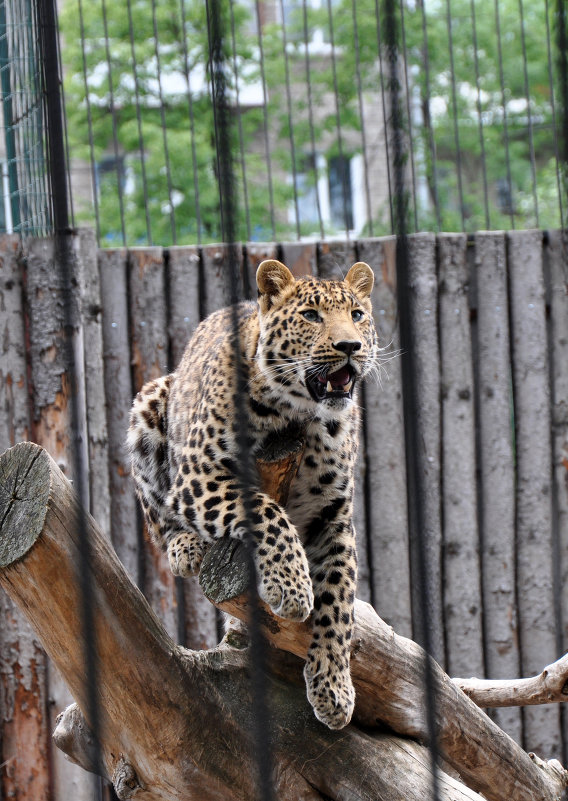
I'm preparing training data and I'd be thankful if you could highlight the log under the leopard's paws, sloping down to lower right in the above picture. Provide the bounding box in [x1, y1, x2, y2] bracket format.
[200, 542, 568, 801]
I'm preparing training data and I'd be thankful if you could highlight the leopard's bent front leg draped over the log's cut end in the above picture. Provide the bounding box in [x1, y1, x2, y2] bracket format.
[170, 466, 313, 620]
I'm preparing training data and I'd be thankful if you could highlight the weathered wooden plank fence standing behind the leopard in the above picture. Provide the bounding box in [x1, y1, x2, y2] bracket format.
[0, 231, 568, 801]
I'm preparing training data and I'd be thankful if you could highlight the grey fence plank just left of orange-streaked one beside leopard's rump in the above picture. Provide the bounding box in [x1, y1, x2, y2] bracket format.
[98, 249, 141, 583]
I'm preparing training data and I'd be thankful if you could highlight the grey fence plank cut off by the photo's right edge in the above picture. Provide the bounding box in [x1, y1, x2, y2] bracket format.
[545, 231, 568, 742]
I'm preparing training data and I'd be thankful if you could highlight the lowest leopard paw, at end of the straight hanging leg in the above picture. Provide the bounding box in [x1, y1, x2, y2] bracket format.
[304, 657, 355, 729]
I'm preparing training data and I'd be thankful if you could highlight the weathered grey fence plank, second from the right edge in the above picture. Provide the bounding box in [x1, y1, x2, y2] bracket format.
[507, 231, 561, 758]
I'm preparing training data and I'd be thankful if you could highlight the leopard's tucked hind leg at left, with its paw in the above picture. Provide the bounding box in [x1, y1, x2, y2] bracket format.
[128, 375, 203, 576]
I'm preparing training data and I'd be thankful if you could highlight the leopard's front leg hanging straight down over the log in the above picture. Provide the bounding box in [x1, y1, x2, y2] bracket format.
[304, 516, 357, 729]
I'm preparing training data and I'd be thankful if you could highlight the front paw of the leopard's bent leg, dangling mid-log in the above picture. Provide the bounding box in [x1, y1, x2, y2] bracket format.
[256, 546, 314, 621]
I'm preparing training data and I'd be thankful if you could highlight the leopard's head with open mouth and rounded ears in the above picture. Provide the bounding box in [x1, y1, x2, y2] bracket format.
[256, 259, 378, 414]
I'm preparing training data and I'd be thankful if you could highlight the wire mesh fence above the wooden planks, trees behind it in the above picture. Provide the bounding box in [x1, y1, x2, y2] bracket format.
[0, 0, 566, 245]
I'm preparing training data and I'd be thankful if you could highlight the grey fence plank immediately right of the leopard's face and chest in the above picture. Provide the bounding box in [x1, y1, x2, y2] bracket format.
[357, 237, 412, 637]
